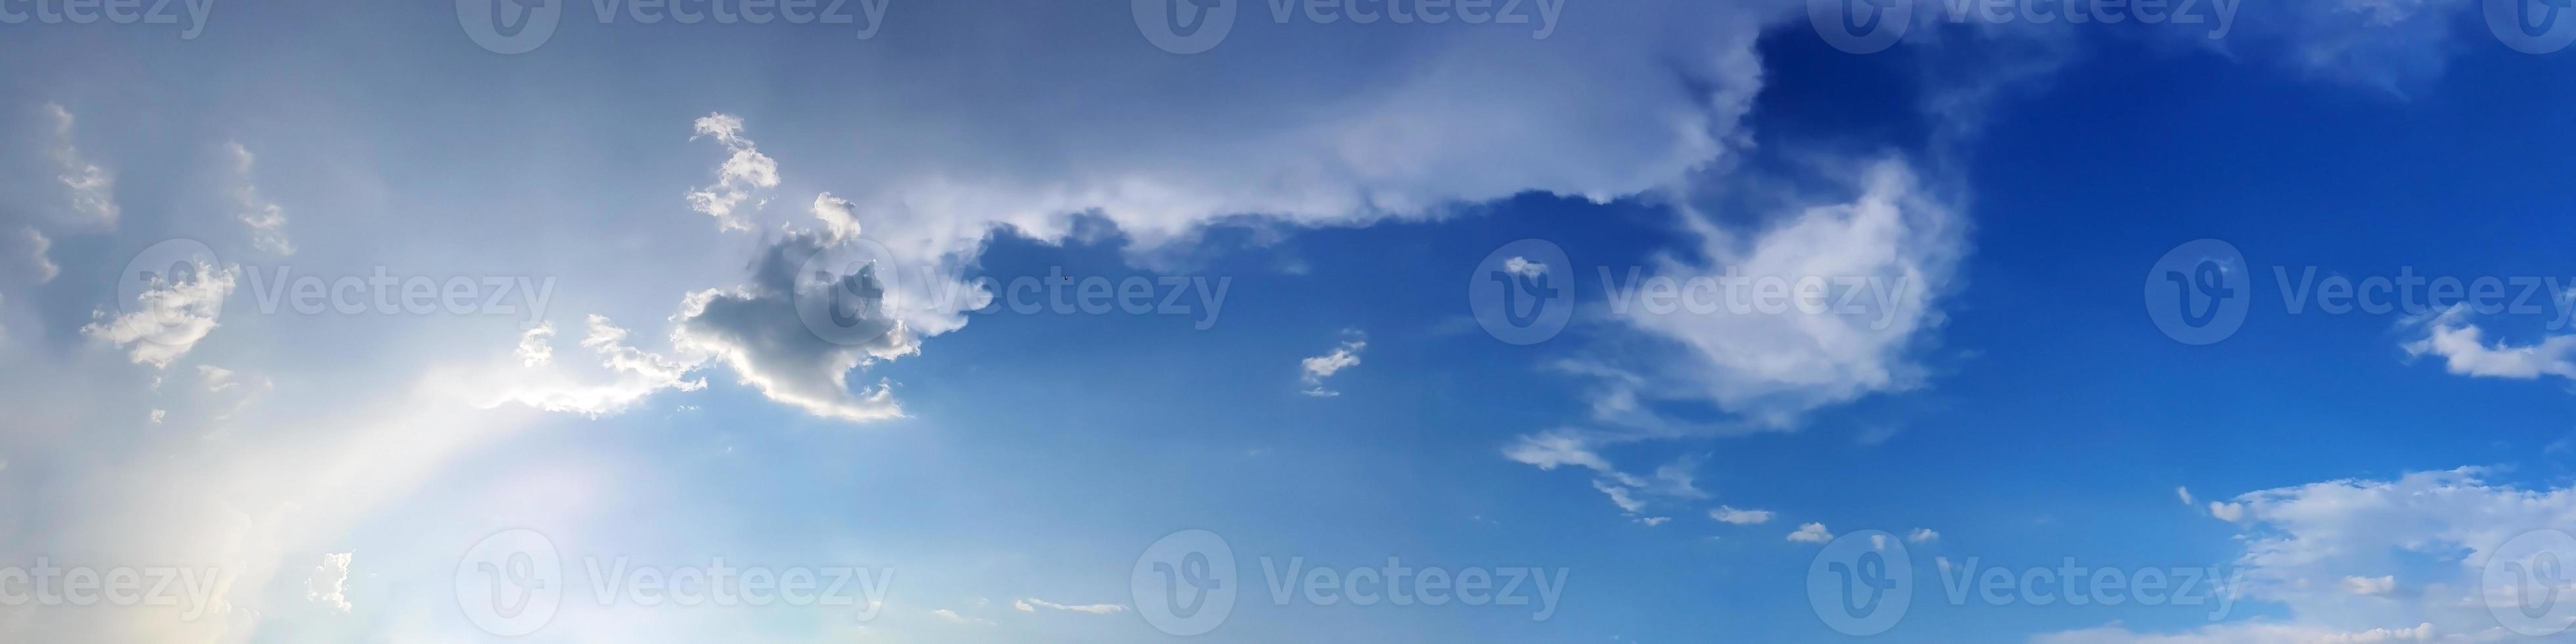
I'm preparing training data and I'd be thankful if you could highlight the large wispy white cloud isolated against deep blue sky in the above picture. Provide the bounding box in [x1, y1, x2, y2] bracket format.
[1592, 160, 1966, 425]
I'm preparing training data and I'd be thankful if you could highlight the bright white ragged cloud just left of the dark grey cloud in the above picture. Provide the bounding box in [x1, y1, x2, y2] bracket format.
[471, 314, 706, 417]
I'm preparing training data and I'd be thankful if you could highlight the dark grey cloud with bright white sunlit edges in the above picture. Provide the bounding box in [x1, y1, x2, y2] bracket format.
[672, 235, 948, 420]
